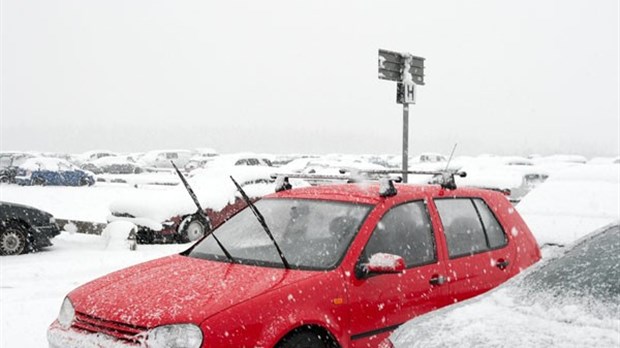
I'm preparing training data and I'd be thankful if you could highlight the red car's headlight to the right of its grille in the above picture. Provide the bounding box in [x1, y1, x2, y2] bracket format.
[146, 324, 202, 348]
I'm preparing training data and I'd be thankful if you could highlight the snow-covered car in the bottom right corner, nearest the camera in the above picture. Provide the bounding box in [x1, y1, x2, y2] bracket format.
[384, 223, 620, 347]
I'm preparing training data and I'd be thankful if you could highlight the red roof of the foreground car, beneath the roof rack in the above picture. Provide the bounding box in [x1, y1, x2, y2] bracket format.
[265, 182, 500, 205]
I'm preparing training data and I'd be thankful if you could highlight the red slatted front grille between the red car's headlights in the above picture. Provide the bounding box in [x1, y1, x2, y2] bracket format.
[72, 312, 147, 345]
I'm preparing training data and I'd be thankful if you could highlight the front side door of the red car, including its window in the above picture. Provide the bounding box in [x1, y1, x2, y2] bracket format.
[349, 200, 449, 347]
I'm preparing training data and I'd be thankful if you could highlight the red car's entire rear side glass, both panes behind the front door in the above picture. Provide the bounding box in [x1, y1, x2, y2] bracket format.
[435, 198, 507, 258]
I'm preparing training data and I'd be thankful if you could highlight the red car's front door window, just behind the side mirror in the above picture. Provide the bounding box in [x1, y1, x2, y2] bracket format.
[364, 201, 436, 267]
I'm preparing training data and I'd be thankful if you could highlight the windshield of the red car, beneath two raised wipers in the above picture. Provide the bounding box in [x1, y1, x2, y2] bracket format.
[189, 198, 372, 270]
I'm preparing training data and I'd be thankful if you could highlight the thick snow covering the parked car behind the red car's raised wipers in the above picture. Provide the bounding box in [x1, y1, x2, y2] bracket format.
[110, 167, 275, 222]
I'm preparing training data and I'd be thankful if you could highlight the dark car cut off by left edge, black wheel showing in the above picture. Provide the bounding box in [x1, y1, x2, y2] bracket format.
[0, 202, 60, 255]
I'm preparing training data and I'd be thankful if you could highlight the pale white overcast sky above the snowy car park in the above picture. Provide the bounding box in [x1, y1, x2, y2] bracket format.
[0, 0, 620, 156]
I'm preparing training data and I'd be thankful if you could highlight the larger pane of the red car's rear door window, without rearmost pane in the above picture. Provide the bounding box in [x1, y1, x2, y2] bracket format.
[435, 198, 488, 258]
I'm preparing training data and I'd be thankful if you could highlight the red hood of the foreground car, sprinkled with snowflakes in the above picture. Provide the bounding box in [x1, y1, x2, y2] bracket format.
[69, 255, 321, 328]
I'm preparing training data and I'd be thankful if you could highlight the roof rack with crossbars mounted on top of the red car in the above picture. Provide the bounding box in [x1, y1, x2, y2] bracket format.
[271, 168, 467, 197]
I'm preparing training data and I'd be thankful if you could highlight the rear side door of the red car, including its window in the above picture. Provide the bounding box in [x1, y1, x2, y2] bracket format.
[434, 197, 514, 302]
